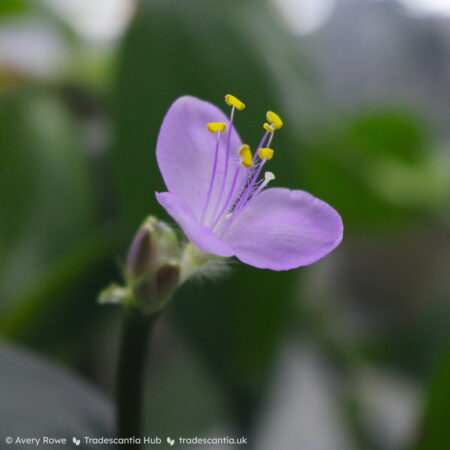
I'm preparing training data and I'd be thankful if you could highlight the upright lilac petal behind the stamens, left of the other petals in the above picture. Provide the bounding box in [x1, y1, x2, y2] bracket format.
[156, 96, 244, 220]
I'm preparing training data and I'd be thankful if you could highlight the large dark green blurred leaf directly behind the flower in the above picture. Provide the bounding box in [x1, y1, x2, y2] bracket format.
[114, 0, 298, 426]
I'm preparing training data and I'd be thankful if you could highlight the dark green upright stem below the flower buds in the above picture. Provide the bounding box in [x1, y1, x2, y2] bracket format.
[116, 309, 158, 450]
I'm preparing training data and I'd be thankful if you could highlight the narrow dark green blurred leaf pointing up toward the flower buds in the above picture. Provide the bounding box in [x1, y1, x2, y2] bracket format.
[0, 230, 116, 347]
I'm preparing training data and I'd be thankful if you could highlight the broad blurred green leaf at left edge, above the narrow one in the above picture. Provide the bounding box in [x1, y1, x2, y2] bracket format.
[0, 87, 93, 309]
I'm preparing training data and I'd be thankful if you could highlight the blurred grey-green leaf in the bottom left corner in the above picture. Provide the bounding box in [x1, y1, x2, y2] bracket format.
[0, 345, 113, 442]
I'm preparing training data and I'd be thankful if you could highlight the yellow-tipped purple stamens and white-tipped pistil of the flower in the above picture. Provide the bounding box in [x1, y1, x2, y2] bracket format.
[201, 94, 283, 235]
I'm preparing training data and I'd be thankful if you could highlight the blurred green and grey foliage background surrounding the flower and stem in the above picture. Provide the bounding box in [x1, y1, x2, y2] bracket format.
[0, 0, 450, 450]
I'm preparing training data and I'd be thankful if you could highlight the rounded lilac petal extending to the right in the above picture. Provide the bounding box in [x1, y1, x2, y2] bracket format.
[223, 188, 343, 270]
